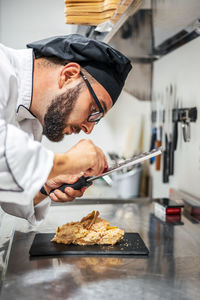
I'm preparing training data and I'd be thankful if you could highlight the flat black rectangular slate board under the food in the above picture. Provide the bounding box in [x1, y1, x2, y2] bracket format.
[29, 232, 149, 256]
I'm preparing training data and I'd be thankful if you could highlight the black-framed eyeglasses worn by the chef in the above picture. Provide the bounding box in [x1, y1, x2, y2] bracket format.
[80, 71, 104, 124]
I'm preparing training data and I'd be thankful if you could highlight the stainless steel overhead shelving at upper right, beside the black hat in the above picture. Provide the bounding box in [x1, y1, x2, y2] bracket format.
[78, 0, 200, 100]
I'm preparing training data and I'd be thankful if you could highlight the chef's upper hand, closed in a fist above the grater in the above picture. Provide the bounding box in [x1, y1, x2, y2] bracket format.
[49, 140, 107, 179]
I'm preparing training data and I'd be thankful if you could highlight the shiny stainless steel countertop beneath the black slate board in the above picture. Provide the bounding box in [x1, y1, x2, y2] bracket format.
[0, 199, 200, 300]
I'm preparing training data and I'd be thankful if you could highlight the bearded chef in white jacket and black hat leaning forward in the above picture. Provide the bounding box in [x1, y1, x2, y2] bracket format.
[0, 34, 131, 224]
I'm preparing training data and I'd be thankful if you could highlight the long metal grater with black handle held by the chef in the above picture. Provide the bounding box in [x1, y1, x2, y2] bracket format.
[50, 147, 162, 193]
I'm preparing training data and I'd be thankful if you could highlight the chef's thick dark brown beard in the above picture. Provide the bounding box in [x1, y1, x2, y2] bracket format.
[43, 83, 82, 142]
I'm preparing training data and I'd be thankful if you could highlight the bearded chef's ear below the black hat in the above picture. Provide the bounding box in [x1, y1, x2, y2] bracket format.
[58, 62, 81, 88]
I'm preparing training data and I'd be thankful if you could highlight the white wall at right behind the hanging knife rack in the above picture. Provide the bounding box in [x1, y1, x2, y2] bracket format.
[151, 38, 200, 197]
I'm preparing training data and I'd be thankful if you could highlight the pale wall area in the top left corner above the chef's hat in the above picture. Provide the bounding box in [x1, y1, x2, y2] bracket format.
[0, 0, 76, 48]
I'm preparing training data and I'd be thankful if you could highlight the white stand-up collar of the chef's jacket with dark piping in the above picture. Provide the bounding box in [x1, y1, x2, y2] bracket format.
[16, 49, 36, 122]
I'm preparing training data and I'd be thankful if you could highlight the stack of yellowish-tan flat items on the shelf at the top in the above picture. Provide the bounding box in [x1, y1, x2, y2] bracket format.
[65, 0, 121, 26]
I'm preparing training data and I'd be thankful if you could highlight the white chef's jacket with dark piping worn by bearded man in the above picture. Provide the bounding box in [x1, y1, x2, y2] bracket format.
[0, 44, 54, 224]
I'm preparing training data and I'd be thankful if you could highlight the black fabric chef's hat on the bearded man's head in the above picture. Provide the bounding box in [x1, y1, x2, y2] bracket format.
[27, 34, 132, 104]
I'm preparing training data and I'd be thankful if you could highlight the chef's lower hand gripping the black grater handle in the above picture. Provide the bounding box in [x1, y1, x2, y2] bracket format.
[44, 175, 86, 202]
